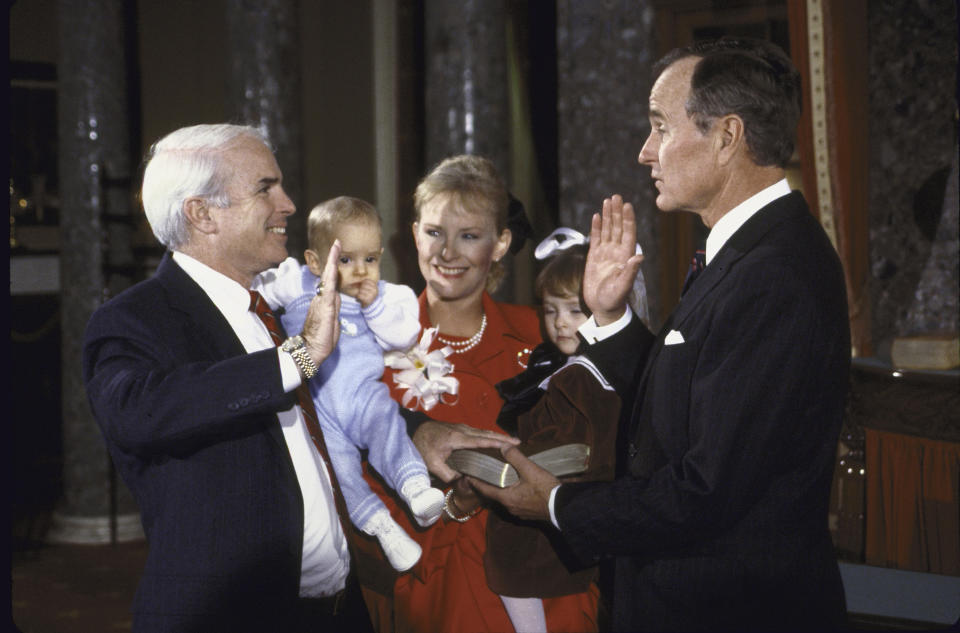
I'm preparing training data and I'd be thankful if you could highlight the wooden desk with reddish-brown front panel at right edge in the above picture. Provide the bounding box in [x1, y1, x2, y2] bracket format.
[831, 359, 960, 575]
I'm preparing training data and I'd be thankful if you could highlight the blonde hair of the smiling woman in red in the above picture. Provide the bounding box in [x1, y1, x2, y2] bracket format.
[413, 154, 510, 293]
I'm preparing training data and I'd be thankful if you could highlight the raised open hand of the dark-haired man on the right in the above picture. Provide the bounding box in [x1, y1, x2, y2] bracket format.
[583, 195, 643, 325]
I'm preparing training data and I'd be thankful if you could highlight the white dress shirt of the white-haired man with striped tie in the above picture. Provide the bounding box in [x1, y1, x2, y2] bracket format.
[173, 252, 350, 598]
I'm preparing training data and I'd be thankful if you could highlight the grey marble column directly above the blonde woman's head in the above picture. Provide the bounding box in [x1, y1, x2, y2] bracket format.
[424, 0, 510, 178]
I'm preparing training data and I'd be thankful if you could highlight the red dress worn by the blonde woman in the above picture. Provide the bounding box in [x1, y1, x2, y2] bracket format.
[368, 293, 599, 633]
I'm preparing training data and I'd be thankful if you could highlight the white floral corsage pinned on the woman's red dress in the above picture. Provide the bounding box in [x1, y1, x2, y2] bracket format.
[383, 327, 460, 411]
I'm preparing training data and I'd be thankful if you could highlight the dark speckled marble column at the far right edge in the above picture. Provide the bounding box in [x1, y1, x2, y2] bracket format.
[867, 0, 960, 346]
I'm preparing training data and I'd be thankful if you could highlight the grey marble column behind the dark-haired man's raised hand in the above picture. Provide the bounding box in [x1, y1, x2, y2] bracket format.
[557, 0, 672, 327]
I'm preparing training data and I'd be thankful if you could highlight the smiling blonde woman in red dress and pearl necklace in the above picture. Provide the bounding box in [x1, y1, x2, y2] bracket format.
[362, 155, 597, 633]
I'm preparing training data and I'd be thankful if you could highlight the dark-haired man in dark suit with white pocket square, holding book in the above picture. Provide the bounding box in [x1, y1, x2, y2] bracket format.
[476, 40, 850, 631]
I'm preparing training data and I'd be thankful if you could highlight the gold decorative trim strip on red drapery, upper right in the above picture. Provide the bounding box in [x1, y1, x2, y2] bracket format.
[807, 0, 837, 248]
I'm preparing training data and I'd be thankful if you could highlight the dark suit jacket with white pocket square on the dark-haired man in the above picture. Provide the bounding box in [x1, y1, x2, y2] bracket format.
[556, 192, 850, 631]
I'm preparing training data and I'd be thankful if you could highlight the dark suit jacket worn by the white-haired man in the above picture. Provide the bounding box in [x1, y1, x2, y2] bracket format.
[83, 254, 318, 631]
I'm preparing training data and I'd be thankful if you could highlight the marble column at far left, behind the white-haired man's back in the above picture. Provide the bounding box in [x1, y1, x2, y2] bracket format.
[47, 0, 143, 543]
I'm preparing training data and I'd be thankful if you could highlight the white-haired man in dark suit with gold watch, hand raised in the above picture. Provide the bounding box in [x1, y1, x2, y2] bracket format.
[83, 124, 370, 632]
